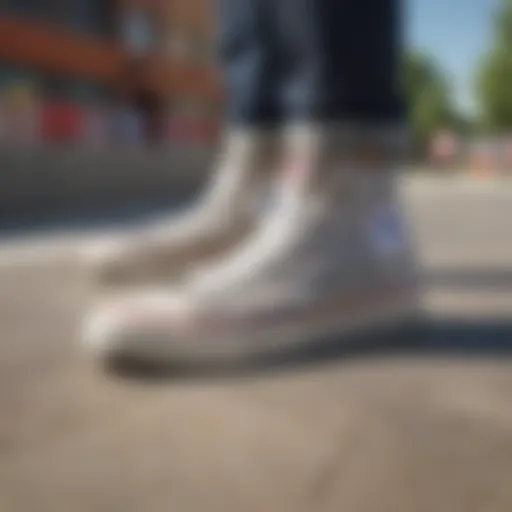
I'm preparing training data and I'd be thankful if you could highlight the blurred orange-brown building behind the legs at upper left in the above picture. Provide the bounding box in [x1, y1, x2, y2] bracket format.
[0, 0, 221, 145]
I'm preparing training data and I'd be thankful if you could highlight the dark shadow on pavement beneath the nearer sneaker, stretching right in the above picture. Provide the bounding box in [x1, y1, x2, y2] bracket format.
[106, 317, 512, 381]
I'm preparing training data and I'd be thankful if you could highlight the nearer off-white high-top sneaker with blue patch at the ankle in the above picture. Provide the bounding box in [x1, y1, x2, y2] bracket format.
[83, 127, 417, 363]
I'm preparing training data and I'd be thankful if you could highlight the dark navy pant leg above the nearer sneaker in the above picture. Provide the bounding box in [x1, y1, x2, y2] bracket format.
[274, 0, 404, 123]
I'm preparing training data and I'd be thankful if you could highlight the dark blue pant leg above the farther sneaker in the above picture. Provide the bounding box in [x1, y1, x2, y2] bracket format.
[217, 0, 283, 126]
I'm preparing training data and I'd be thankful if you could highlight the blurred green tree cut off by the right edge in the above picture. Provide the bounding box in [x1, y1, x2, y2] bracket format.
[476, 0, 512, 133]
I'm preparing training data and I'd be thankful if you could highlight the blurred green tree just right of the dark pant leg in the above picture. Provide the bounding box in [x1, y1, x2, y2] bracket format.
[403, 52, 461, 151]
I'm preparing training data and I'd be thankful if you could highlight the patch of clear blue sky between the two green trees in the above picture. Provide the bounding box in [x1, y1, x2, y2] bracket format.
[406, 0, 499, 110]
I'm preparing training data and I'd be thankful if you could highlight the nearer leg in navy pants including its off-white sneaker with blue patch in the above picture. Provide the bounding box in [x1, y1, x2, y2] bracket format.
[86, 0, 415, 362]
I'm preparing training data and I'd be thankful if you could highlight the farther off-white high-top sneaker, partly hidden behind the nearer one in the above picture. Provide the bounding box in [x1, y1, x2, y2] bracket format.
[85, 131, 277, 285]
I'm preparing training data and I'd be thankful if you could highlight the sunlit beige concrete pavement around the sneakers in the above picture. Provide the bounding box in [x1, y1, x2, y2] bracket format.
[0, 180, 512, 512]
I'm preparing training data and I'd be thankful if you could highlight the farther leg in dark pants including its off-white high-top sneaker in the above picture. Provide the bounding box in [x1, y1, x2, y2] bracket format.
[88, 0, 282, 286]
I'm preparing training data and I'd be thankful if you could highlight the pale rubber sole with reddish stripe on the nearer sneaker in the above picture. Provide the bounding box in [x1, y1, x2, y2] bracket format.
[83, 282, 421, 366]
